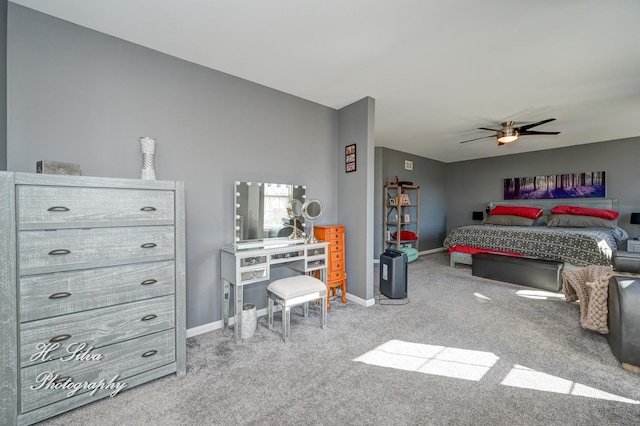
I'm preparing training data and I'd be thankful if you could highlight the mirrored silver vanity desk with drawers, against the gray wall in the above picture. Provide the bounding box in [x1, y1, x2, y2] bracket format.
[220, 238, 329, 343]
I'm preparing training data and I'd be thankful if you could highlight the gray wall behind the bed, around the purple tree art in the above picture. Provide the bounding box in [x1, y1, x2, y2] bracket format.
[446, 137, 640, 237]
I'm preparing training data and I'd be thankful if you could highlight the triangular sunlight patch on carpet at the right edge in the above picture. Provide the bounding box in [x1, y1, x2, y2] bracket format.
[501, 364, 640, 404]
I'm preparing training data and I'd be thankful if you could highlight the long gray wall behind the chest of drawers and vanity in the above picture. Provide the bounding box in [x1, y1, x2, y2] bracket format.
[7, 3, 343, 328]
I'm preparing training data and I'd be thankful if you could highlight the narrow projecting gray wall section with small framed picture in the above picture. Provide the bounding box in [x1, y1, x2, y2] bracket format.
[336, 98, 375, 305]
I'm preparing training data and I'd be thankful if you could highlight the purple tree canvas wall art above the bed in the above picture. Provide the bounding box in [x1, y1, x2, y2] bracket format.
[504, 172, 606, 200]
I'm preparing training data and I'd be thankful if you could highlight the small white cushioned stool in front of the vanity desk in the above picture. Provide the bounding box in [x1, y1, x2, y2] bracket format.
[267, 275, 327, 343]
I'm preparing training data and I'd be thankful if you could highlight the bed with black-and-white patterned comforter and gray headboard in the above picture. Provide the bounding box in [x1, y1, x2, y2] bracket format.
[443, 198, 628, 267]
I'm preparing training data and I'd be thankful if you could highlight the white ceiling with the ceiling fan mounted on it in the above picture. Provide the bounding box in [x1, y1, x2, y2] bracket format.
[12, 0, 640, 162]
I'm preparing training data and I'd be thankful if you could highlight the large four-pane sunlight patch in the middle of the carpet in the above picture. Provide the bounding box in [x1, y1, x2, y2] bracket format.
[354, 340, 499, 381]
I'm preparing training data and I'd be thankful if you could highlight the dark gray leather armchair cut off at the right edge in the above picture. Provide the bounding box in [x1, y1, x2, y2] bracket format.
[607, 251, 640, 373]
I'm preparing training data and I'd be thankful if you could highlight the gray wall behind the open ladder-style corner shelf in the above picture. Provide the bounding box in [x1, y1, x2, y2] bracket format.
[374, 147, 447, 258]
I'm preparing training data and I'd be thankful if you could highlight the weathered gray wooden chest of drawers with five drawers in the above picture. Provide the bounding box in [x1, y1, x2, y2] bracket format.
[0, 172, 186, 425]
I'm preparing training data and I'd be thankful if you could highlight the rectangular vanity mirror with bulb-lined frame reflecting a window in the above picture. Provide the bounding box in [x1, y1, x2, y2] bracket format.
[234, 182, 307, 246]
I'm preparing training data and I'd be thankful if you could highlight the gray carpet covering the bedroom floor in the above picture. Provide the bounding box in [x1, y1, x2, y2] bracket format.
[42, 253, 640, 425]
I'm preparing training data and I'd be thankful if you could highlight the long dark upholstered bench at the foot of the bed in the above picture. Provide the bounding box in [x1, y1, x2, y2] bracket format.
[471, 253, 563, 292]
